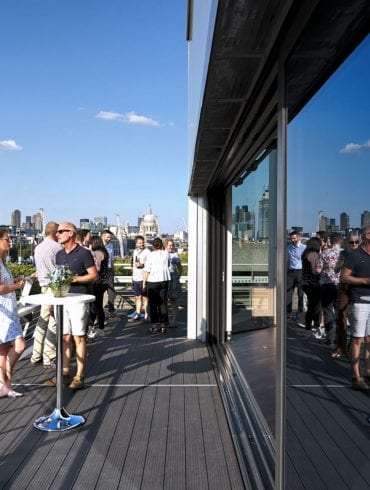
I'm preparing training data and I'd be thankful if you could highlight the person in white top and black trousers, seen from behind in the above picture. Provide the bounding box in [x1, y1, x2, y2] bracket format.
[143, 238, 171, 333]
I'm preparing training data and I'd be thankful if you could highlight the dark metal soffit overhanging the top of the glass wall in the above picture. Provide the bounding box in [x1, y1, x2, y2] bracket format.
[189, 0, 370, 195]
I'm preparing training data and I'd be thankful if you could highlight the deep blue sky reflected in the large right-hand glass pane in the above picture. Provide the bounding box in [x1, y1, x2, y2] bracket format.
[287, 37, 370, 232]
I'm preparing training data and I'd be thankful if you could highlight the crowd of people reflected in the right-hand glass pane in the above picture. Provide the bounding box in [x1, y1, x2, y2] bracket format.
[286, 226, 370, 391]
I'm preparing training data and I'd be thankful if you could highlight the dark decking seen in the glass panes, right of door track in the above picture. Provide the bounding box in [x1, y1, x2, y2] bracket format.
[232, 321, 370, 490]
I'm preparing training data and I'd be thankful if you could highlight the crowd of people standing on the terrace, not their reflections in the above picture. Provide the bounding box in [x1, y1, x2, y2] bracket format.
[0, 221, 181, 397]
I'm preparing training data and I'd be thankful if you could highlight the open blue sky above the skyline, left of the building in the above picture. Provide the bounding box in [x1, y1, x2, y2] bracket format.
[0, 0, 188, 233]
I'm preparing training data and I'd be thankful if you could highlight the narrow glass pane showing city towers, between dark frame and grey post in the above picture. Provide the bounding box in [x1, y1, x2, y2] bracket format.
[231, 156, 275, 432]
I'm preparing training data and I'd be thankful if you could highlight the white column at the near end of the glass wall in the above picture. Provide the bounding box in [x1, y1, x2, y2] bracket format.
[187, 196, 207, 342]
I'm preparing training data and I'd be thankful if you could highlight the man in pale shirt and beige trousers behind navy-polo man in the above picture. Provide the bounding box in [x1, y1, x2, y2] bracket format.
[31, 221, 63, 367]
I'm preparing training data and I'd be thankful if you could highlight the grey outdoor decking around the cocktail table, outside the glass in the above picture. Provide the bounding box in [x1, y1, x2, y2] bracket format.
[0, 316, 244, 490]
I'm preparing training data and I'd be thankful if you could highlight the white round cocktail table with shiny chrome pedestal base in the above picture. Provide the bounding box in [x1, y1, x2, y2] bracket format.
[20, 293, 95, 432]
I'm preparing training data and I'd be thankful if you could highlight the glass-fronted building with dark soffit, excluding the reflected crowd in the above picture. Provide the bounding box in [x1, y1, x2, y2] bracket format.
[187, 0, 370, 489]
